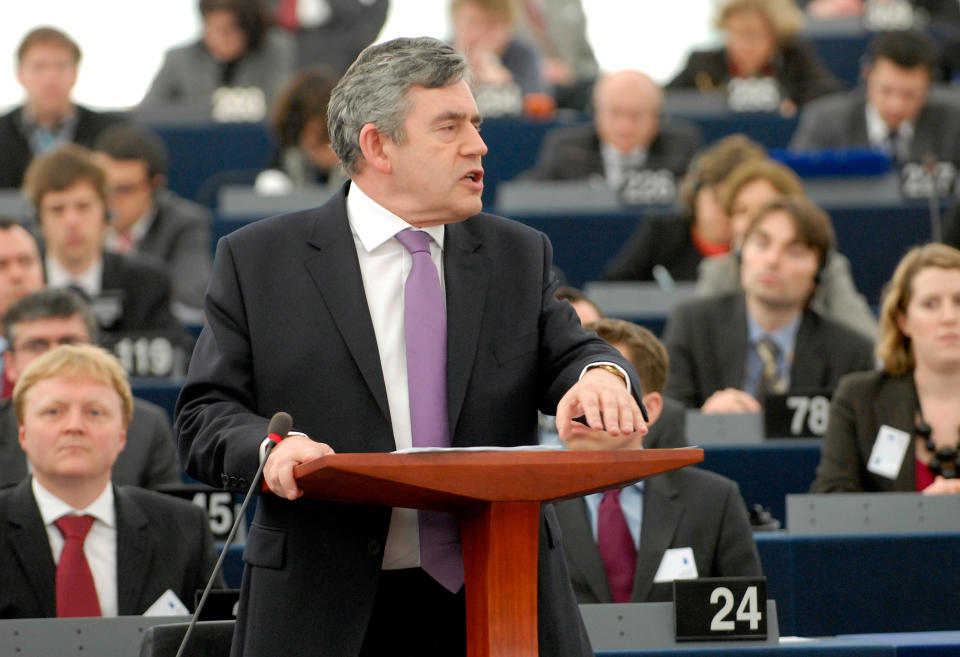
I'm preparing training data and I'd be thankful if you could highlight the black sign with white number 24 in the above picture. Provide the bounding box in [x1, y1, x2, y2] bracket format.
[673, 577, 767, 641]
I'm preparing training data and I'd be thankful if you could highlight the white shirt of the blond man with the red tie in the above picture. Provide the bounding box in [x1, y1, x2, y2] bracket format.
[31, 477, 119, 617]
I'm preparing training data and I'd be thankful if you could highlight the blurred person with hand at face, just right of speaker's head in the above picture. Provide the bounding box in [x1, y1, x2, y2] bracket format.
[450, 0, 552, 116]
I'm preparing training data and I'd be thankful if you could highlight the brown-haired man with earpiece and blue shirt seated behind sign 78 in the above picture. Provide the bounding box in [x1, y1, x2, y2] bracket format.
[663, 197, 874, 413]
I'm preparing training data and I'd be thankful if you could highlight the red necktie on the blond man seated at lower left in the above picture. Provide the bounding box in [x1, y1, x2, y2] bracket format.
[54, 516, 101, 618]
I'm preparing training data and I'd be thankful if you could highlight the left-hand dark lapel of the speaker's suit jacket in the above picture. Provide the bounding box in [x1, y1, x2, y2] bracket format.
[306, 193, 390, 419]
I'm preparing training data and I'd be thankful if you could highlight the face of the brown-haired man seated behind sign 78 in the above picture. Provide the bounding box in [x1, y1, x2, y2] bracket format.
[740, 210, 818, 312]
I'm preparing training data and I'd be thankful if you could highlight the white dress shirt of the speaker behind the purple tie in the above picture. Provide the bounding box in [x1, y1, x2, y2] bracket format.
[347, 183, 446, 570]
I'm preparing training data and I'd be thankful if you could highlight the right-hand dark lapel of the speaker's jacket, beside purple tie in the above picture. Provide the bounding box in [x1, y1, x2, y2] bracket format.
[443, 223, 492, 436]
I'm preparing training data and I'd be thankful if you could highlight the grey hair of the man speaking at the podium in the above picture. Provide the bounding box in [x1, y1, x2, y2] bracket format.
[327, 37, 469, 173]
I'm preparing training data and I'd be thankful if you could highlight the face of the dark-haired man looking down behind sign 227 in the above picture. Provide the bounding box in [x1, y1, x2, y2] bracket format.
[867, 57, 930, 130]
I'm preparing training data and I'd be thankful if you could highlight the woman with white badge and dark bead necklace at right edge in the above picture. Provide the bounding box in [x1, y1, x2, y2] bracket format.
[811, 244, 960, 494]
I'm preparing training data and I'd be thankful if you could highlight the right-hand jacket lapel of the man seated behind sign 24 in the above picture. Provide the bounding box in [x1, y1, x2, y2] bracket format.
[632, 477, 683, 602]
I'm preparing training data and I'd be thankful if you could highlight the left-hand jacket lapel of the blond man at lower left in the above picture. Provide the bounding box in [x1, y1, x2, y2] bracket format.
[3, 478, 57, 617]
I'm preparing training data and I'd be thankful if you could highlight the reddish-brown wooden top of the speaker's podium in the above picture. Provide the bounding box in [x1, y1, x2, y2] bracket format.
[294, 448, 703, 510]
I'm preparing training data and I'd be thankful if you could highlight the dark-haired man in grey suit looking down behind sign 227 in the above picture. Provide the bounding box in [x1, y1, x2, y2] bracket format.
[790, 31, 960, 166]
